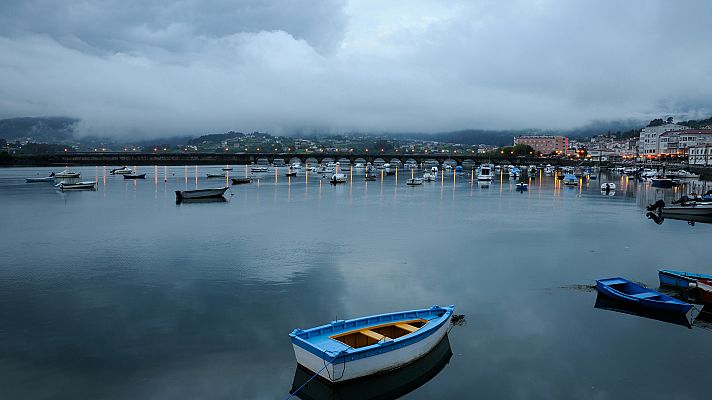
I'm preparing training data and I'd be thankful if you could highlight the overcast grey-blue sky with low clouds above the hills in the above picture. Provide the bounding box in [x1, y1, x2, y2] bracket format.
[0, 0, 712, 137]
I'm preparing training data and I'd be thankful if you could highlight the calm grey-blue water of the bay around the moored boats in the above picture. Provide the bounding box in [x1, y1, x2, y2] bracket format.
[0, 166, 712, 399]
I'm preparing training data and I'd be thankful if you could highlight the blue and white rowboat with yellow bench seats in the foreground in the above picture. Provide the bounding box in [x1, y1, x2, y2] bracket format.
[289, 306, 455, 383]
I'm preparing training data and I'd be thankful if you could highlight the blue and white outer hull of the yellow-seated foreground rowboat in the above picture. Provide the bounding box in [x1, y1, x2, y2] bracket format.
[290, 307, 453, 383]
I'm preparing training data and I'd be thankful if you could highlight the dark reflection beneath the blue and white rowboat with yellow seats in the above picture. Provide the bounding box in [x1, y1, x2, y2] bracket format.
[290, 335, 452, 400]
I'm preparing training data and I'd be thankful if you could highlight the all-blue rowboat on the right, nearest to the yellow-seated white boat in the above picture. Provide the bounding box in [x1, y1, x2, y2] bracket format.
[596, 278, 692, 314]
